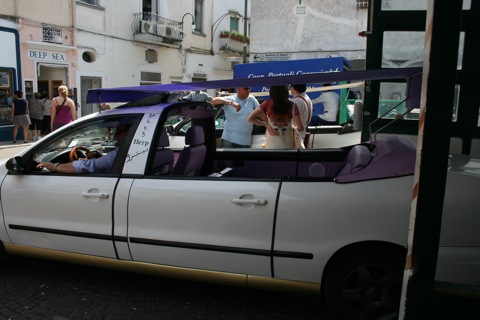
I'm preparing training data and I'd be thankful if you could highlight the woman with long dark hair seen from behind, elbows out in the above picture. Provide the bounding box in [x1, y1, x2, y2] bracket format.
[248, 86, 303, 149]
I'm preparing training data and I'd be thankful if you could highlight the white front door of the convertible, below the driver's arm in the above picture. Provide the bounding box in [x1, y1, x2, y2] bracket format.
[2, 175, 117, 258]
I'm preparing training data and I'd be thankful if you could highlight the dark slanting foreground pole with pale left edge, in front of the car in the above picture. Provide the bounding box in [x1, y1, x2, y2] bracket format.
[400, 0, 462, 320]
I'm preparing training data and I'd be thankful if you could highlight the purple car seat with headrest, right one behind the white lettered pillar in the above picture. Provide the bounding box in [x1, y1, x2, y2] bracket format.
[173, 126, 207, 176]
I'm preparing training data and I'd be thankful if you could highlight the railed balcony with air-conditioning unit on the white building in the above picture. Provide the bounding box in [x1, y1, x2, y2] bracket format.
[132, 12, 185, 45]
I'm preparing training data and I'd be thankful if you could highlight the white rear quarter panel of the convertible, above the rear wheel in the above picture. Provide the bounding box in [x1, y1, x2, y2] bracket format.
[275, 176, 413, 282]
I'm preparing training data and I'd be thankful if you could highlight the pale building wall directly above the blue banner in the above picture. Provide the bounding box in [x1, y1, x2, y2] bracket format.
[250, 0, 368, 62]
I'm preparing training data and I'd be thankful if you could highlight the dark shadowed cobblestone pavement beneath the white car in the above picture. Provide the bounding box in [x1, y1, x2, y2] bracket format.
[0, 257, 331, 320]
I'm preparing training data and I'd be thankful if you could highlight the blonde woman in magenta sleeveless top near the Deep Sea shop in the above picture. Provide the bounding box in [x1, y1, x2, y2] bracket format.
[50, 86, 77, 131]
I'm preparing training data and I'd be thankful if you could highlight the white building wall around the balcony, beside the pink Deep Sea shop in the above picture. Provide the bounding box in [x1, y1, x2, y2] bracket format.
[76, 0, 192, 111]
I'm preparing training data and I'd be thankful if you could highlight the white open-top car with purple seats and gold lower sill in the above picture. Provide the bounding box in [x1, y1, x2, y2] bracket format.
[0, 84, 480, 319]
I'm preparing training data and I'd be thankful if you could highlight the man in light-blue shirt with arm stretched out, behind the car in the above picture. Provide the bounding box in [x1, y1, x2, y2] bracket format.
[212, 87, 259, 148]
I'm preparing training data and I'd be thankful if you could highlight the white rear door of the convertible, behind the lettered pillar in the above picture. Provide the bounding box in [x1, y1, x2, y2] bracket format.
[128, 179, 279, 276]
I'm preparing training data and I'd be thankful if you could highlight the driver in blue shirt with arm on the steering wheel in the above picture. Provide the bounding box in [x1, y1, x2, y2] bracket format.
[37, 124, 130, 173]
